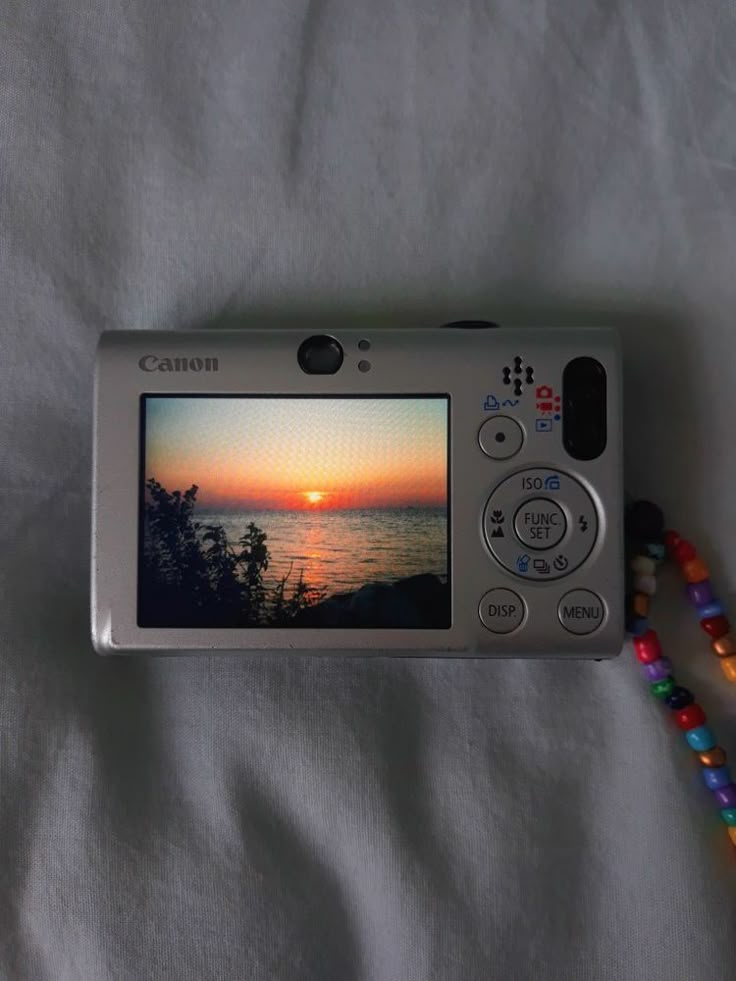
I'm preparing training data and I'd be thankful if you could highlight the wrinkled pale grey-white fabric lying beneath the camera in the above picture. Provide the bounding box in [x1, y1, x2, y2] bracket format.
[0, 0, 736, 981]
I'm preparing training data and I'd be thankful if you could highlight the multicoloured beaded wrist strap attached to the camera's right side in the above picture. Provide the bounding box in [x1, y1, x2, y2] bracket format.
[626, 501, 736, 846]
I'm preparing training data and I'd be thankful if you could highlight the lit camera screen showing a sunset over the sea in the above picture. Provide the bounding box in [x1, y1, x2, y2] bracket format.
[138, 396, 450, 629]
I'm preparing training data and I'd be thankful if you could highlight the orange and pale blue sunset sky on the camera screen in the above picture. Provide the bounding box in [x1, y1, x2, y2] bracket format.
[146, 396, 448, 510]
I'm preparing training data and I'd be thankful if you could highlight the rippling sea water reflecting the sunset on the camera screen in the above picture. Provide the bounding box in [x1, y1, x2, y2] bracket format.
[195, 507, 448, 595]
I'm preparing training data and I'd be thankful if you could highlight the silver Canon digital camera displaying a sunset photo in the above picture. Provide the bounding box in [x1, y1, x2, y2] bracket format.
[92, 322, 624, 658]
